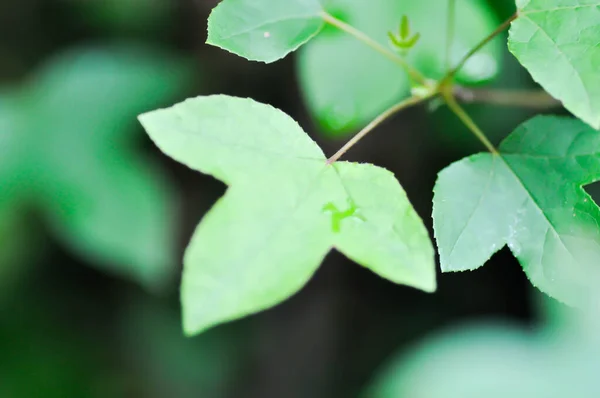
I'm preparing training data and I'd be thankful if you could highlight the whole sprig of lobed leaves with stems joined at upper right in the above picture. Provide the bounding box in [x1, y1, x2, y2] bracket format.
[140, 0, 600, 334]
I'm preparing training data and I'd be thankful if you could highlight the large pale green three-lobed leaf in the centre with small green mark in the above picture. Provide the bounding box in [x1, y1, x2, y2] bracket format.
[140, 96, 435, 334]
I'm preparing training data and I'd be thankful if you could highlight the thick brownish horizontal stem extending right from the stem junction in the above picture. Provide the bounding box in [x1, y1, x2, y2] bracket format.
[453, 86, 562, 109]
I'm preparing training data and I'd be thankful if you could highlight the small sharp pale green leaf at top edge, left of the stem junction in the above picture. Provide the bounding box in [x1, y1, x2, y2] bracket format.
[206, 0, 323, 62]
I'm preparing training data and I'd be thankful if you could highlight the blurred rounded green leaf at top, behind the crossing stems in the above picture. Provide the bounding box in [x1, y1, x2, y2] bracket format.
[298, 0, 502, 136]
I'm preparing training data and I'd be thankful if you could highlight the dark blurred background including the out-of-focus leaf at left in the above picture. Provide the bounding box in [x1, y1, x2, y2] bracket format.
[0, 0, 588, 398]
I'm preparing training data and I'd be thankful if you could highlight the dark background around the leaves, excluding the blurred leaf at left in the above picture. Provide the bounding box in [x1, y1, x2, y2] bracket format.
[0, 0, 556, 398]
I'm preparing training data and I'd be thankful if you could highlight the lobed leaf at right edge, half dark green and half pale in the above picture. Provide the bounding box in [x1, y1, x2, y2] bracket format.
[433, 116, 600, 305]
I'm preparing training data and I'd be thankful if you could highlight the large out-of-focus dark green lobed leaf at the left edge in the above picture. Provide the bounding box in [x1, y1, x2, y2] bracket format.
[0, 46, 184, 286]
